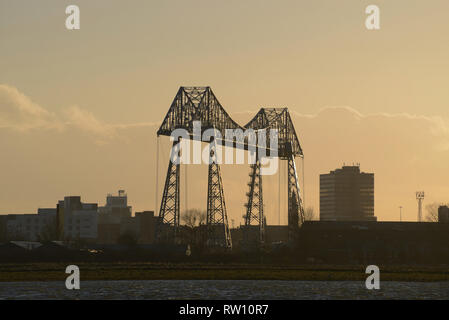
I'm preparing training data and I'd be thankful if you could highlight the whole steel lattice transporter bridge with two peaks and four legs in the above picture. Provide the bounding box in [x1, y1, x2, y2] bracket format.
[157, 87, 304, 248]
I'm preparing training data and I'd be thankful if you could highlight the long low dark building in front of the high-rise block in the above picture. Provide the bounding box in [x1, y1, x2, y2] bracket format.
[298, 221, 449, 266]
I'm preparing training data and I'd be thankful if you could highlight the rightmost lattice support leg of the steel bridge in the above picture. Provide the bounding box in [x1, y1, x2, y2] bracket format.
[287, 155, 304, 243]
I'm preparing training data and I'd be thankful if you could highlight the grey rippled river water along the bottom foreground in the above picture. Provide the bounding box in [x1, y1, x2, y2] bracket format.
[0, 280, 449, 300]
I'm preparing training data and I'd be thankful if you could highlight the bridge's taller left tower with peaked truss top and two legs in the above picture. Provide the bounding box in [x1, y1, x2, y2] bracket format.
[156, 87, 236, 250]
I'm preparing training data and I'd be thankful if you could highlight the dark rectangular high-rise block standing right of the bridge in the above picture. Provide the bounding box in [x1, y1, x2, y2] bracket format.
[320, 166, 377, 221]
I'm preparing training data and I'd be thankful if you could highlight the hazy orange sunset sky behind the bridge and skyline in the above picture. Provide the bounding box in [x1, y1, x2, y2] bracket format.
[0, 0, 449, 225]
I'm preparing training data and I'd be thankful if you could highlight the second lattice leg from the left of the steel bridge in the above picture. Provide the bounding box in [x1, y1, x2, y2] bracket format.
[206, 151, 232, 250]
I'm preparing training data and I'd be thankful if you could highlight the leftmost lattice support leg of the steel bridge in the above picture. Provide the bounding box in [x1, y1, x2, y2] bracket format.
[156, 141, 180, 243]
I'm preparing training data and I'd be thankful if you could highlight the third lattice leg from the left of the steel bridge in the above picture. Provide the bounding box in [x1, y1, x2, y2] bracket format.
[243, 160, 265, 248]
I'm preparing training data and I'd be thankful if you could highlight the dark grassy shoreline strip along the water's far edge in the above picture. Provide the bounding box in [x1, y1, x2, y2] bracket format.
[0, 262, 449, 282]
